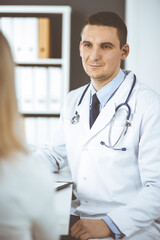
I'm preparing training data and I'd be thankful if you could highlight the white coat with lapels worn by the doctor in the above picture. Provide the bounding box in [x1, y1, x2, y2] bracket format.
[39, 72, 160, 240]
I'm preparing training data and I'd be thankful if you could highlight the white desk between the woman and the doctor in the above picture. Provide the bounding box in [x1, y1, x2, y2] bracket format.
[55, 168, 72, 235]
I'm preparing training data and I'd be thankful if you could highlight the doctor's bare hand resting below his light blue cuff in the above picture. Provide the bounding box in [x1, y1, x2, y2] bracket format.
[71, 219, 112, 240]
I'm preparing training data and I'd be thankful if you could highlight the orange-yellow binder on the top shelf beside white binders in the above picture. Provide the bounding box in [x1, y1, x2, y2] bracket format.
[38, 18, 50, 58]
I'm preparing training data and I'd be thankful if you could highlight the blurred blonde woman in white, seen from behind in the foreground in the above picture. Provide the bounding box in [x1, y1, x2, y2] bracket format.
[0, 32, 58, 240]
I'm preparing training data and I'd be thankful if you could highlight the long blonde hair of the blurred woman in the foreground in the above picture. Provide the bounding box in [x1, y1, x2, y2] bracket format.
[0, 32, 27, 158]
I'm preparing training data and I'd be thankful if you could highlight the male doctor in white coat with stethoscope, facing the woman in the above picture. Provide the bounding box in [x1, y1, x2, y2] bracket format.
[38, 12, 160, 240]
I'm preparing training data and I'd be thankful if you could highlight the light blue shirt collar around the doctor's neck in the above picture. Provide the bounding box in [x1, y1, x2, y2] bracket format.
[91, 69, 125, 108]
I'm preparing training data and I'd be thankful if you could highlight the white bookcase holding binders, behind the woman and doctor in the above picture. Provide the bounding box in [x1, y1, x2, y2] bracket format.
[0, 5, 71, 146]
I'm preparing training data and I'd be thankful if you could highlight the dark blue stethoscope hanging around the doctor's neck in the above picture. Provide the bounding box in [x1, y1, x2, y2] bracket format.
[71, 75, 136, 151]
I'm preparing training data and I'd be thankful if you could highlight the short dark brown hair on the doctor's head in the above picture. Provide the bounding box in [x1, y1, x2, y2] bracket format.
[81, 12, 127, 48]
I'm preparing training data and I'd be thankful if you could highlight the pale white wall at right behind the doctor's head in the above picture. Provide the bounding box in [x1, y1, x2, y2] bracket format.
[125, 0, 160, 93]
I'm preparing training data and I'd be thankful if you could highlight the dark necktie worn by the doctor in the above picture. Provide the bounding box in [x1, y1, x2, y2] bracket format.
[90, 93, 99, 128]
